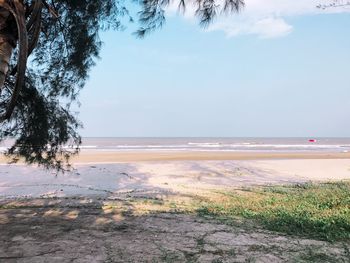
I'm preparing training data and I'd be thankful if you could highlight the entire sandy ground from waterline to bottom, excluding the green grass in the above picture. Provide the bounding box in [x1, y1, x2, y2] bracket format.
[0, 151, 350, 263]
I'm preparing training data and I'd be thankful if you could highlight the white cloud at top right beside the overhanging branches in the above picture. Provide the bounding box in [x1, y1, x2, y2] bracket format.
[170, 0, 350, 38]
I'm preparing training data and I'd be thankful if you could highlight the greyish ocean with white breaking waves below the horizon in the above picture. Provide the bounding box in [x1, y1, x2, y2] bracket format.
[72, 137, 350, 152]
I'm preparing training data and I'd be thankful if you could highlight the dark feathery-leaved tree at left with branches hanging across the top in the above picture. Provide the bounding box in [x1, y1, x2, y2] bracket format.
[0, 0, 244, 169]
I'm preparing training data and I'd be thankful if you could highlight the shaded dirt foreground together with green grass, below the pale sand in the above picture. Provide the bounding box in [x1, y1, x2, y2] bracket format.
[0, 181, 350, 262]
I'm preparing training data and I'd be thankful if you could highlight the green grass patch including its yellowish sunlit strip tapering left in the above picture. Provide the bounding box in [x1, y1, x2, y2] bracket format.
[99, 181, 350, 242]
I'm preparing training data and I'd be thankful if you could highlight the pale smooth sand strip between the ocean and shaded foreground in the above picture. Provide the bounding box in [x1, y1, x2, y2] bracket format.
[0, 151, 350, 198]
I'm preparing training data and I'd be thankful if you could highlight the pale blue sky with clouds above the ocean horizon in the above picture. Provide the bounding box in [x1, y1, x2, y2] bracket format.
[79, 0, 350, 137]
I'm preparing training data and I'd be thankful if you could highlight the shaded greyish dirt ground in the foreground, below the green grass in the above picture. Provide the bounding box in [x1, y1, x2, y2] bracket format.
[0, 197, 350, 263]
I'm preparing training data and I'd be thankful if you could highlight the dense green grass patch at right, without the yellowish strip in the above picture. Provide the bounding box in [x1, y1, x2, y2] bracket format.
[197, 181, 350, 241]
